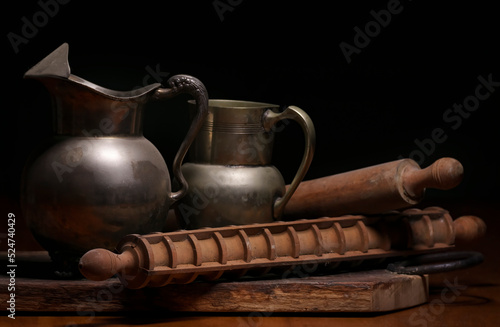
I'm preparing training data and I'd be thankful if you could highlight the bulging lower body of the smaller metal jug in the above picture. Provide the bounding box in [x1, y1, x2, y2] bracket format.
[175, 163, 285, 229]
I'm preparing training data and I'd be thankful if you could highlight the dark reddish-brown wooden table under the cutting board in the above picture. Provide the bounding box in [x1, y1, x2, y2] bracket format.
[0, 202, 500, 327]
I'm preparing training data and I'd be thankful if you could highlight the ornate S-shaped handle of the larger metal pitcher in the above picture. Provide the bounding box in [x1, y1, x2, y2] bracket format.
[154, 75, 208, 202]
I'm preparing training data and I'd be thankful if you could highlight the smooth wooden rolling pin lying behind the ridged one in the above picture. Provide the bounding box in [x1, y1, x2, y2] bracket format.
[283, 158, 464, 220]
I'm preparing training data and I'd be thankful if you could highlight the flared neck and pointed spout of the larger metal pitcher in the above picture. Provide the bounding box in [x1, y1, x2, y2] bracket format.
[24, 43, 161, 136]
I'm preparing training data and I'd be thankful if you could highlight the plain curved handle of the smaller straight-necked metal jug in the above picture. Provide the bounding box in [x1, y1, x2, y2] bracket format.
[263, 106, 316, 219]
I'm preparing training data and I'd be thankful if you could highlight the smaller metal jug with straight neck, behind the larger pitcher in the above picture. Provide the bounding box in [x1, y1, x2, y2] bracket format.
[174, 100, 316, 228]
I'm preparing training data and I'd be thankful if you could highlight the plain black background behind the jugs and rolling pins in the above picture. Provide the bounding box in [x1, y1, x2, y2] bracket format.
[0, 0, 500, 210]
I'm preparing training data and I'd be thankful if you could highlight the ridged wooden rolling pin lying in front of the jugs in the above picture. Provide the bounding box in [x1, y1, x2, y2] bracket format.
[79, 208, 485, 289]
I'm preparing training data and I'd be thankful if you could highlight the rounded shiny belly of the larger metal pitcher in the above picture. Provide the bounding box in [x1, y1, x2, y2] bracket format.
[21, 137, 170, 254]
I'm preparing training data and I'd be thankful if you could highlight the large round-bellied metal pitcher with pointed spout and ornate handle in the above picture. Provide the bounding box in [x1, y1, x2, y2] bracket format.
[21, 44, 208, 270]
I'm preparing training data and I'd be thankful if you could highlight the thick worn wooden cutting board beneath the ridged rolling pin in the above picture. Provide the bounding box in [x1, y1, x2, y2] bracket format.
[0, 252, 429, 315]
